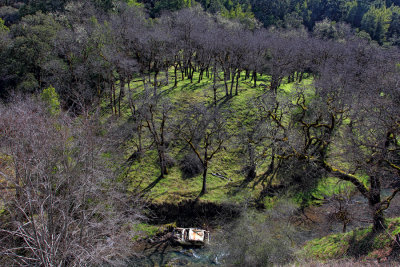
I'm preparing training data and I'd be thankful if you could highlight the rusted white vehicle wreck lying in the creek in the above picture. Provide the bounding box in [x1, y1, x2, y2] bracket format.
[173, 228, 210, 246]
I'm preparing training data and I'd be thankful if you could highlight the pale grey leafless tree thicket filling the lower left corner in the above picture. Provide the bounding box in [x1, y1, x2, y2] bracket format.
[0, 99, 140, 266]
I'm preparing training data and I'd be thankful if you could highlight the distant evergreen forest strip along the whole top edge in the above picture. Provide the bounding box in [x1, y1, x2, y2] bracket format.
[0, 0, 400, 45]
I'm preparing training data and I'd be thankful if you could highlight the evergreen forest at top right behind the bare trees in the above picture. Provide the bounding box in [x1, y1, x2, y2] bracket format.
[139, 0, 400, 45]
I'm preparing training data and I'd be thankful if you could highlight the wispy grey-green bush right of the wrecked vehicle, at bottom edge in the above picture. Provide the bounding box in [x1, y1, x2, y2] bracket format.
[216, 201, 296, 266]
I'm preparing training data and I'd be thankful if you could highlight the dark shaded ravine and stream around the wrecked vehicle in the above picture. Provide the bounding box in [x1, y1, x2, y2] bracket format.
[127, 200, 241, 266]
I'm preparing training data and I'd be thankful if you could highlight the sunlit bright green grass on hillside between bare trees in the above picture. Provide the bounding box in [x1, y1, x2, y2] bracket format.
[116, 71, 312, 203]
